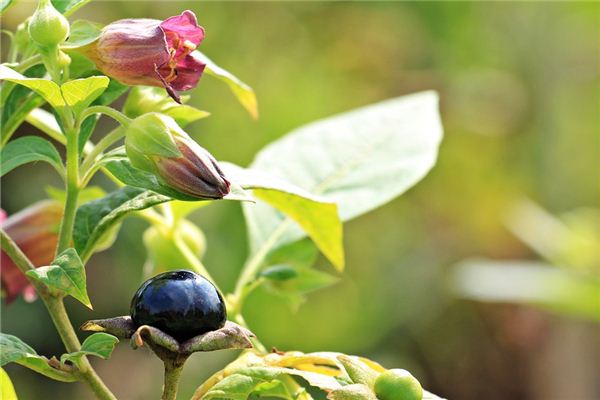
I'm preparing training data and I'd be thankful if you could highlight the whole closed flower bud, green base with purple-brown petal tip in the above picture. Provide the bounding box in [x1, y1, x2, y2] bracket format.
[125, 113, 229, 199]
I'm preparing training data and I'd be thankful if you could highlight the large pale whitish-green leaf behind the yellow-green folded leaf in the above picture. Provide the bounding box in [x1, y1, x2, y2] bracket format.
[244, 92, 442, 266]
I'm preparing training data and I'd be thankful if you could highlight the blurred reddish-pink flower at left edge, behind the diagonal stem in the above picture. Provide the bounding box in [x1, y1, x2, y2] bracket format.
[0, 200, 63, 303]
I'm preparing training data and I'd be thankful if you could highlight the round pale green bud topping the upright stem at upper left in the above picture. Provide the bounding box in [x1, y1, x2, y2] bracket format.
[29, 0, 69, 46]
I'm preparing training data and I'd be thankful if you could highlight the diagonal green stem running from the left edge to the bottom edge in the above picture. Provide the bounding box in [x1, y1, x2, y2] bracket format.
[0, 229, 116, 400]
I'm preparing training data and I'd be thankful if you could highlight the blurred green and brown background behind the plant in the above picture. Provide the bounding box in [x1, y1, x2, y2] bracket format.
[1, 1, 600, 400]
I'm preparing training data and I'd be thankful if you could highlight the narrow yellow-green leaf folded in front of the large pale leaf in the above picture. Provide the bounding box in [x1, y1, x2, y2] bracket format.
[221, 163, 344, 271]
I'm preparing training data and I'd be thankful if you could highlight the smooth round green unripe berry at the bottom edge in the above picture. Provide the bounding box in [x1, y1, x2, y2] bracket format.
[373, 369, 423, 400]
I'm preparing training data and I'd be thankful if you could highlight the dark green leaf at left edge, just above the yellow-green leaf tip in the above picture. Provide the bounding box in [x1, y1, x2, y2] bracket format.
[0, 333, 77, 382]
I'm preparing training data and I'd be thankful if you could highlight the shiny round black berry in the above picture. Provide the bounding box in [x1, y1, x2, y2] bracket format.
[131, 270, 227, 341]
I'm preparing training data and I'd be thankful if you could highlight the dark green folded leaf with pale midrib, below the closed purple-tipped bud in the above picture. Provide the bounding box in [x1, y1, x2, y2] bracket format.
[73, 187, 170, 260]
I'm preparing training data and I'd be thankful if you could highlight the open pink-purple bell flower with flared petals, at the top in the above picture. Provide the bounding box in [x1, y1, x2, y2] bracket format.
[79, 10, 205, 102]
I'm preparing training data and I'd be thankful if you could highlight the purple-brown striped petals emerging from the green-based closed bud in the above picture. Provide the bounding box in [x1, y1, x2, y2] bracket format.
[154, 136, 229, 199]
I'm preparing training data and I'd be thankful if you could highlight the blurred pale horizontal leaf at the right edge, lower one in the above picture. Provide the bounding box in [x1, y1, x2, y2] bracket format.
[450, 260, 600, 321]
